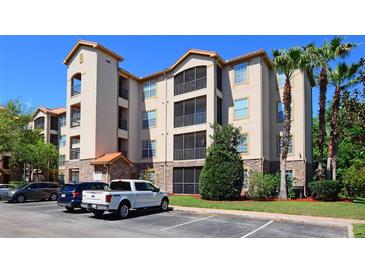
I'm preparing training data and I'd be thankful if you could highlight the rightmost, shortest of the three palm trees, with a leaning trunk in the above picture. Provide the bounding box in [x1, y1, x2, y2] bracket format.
[327, 61, 363, 181]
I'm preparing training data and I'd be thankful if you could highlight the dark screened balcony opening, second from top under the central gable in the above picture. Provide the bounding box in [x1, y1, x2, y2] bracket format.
[174, 96, 207, 128]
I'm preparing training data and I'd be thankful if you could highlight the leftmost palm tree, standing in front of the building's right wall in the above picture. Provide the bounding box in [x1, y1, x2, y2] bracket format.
[272, 47, 308, 200]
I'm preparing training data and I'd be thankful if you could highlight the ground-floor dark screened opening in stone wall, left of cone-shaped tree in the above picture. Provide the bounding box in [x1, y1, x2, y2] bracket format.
[173, 167, 202, 194]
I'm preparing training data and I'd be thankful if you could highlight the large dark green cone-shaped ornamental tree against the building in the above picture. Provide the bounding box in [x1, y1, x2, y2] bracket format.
[199, 124, 243, 200]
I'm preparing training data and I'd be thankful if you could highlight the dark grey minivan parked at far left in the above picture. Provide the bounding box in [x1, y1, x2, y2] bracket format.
[4, 182, 59, 203]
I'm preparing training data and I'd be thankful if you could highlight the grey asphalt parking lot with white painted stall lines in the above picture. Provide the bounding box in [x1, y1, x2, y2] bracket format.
[0, 201, 348, 238]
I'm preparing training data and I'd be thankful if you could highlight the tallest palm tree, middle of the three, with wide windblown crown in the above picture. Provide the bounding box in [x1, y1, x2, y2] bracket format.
[305, 37, 357, 179]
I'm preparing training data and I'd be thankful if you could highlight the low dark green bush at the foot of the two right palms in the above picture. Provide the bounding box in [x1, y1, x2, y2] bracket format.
[310, 180, 342, 201]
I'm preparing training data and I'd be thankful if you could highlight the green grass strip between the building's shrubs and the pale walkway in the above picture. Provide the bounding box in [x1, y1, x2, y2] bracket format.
[169, 196, 365, 219]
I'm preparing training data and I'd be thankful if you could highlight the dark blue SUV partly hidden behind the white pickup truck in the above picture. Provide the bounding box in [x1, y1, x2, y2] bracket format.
[57, 182, 108, 212]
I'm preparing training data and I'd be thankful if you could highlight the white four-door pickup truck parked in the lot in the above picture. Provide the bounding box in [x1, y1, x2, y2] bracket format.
[81, 180, 169, 219]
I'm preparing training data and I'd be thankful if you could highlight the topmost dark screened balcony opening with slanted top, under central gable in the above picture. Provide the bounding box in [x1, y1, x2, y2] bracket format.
[174, 66, 207, 95]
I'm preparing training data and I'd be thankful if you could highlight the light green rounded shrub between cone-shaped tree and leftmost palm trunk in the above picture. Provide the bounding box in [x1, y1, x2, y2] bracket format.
[247, 172, 280, 200]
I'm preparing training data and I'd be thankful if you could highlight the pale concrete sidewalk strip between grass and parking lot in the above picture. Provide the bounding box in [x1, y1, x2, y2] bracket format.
[172, 206, 365, 229]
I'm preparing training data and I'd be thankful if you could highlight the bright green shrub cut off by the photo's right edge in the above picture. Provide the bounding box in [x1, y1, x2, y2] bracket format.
[343, 166, 365, 199]
